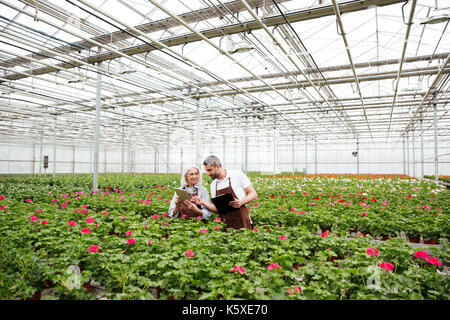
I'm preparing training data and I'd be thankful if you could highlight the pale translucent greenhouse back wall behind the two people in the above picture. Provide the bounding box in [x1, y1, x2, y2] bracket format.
[0, 139, 450, 177]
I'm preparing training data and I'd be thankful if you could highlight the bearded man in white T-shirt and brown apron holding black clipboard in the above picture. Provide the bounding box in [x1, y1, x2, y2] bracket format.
[192, 155, 257, 229]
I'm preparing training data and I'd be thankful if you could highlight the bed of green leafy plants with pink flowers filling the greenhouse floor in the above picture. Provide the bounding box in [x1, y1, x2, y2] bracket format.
[0, 175, 450, 299]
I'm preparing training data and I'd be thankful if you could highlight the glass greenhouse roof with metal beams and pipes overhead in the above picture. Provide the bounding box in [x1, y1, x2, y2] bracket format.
[0, 0, 450, 148]
